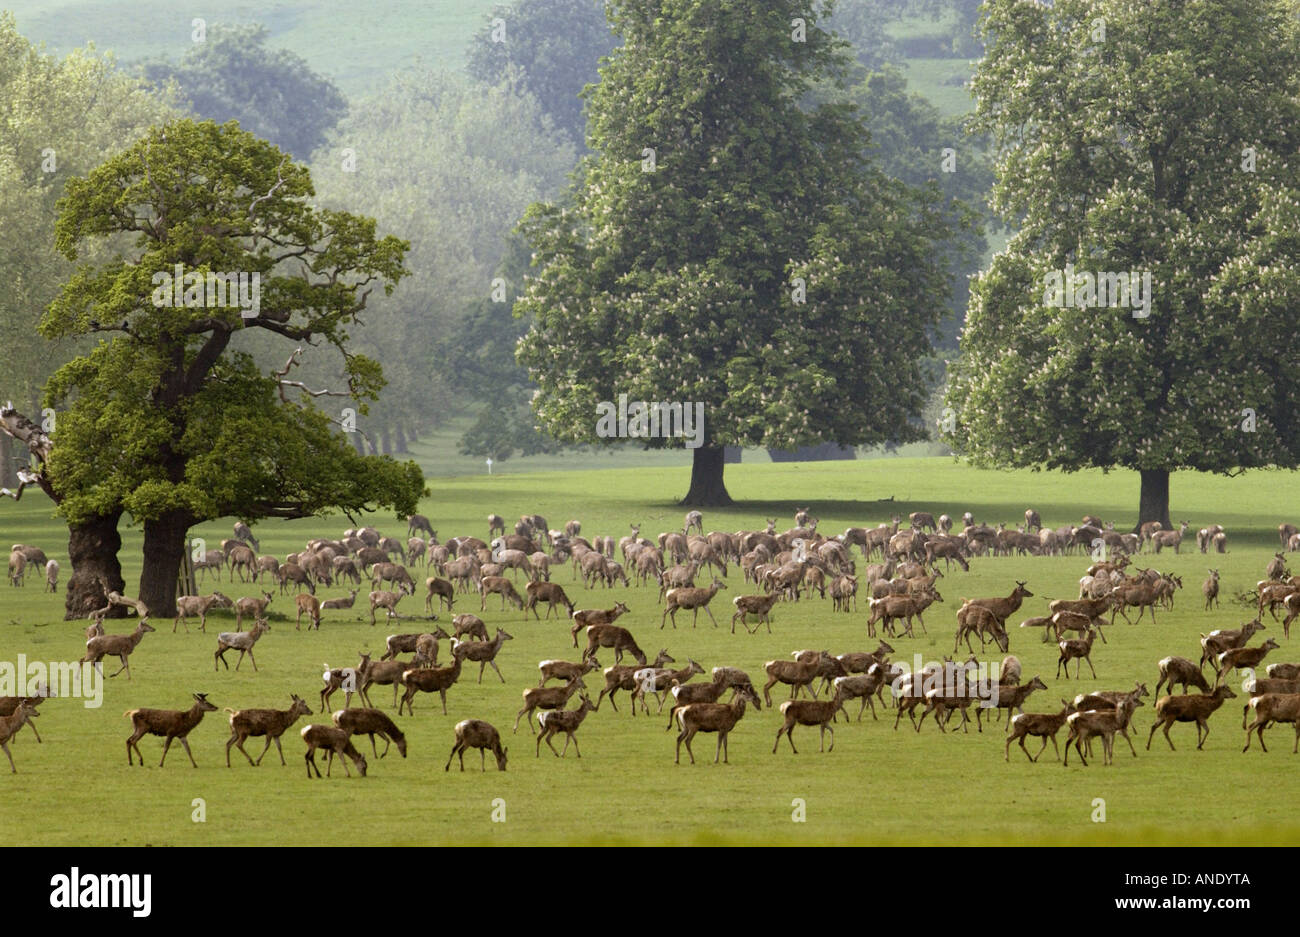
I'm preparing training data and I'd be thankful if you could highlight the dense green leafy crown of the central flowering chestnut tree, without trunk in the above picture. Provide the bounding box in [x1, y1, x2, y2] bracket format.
[517, 0, 948, 448]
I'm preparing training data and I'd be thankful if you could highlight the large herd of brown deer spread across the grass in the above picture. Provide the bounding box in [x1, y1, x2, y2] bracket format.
[0, 509, 1300, 777]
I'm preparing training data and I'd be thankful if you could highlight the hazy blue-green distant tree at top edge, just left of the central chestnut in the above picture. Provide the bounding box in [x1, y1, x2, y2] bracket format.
[467, 0, 616, 146]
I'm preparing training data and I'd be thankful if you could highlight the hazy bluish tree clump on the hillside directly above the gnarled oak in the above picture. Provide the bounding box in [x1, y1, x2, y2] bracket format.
[142, 23, 347, 160]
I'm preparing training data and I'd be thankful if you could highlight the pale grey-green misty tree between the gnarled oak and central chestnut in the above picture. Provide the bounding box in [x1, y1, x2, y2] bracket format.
[312, 70, 575, 449]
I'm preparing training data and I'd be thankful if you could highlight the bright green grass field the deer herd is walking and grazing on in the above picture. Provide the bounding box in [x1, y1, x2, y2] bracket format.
[0, 459, 1300, 845]
